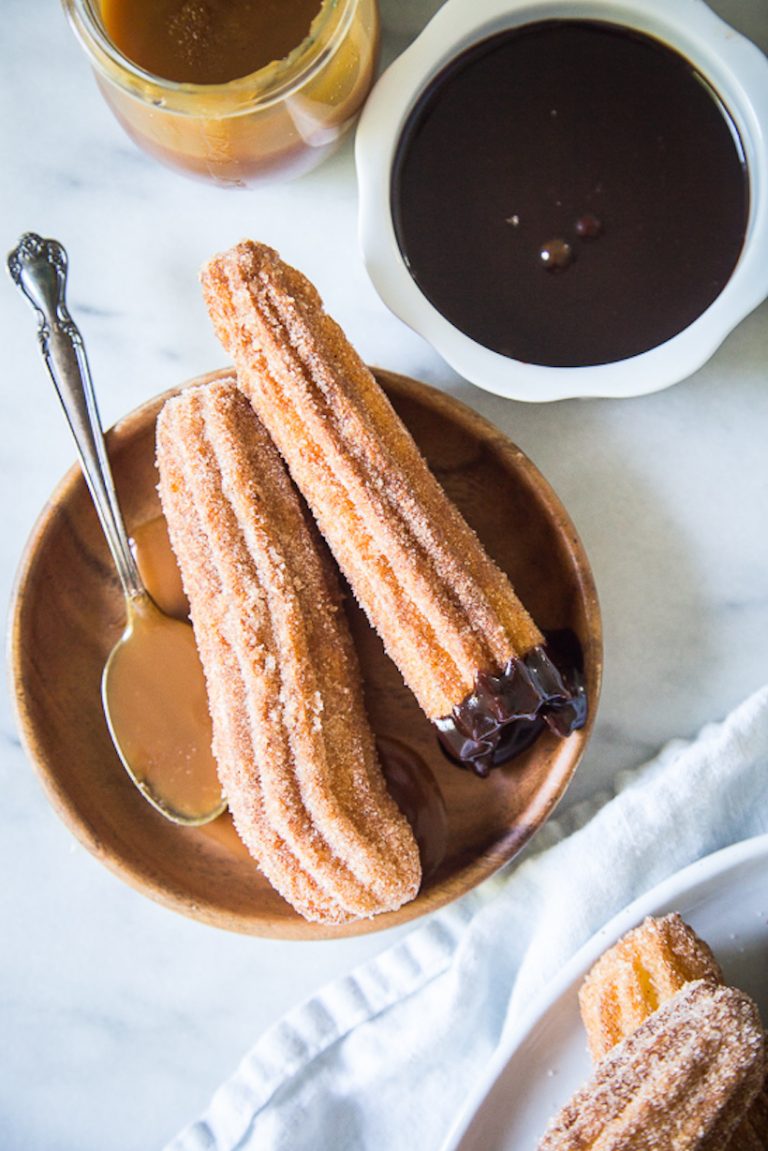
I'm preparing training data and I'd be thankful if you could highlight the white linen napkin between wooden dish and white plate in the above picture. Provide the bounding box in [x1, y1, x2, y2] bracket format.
[166, 686, 768, 1151]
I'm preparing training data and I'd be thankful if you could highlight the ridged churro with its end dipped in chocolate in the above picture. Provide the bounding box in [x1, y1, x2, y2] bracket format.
[201, 242, 586, 775]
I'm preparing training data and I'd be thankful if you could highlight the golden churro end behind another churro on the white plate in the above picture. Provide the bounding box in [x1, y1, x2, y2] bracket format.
[579, 913, 723, 1060]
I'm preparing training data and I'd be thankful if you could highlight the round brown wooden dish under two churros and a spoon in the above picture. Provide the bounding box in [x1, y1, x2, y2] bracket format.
[10, 369, 602, 939]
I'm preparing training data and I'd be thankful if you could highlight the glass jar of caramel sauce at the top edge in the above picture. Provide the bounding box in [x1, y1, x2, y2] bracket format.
[63, 0, 379, 186]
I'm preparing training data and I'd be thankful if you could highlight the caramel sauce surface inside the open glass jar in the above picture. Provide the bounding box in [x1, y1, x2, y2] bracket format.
[101, 0, 320, 84]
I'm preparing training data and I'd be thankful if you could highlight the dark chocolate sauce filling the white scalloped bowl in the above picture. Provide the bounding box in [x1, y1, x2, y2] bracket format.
[391, 21, 750, 366]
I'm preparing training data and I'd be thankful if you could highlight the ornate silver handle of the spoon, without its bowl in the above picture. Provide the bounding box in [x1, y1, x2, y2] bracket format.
[8, 231, 146, 599]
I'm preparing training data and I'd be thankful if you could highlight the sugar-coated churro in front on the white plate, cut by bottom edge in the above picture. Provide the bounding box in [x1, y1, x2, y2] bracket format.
[539, 980, 765, 1151]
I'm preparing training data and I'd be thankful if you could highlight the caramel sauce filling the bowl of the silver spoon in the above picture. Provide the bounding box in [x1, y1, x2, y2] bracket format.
[104, 597, 221, 822]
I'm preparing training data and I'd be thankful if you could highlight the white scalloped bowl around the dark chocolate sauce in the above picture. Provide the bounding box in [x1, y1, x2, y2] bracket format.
[356, 0, 768, 402]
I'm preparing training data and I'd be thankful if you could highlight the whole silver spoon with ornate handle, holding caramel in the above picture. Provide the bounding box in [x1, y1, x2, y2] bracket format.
[8, 233, 226, 826]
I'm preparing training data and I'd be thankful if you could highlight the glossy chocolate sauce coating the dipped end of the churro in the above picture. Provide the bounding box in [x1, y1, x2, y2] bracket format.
[435, 631, 587, 778]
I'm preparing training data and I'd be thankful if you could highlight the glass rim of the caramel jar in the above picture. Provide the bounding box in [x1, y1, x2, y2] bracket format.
[62, 0, 358, 120]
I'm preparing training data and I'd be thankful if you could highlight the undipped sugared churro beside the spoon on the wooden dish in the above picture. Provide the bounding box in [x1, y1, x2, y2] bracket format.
[157, 381, 420, 923]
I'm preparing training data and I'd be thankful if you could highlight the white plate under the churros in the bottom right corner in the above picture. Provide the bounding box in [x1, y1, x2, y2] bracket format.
[442, 836, 768, 1151]
